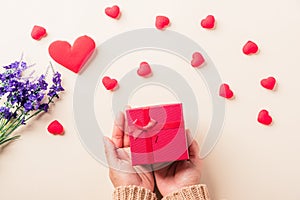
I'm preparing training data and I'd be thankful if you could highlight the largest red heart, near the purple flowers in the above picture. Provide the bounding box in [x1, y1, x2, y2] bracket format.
[48, 35, 96, 73]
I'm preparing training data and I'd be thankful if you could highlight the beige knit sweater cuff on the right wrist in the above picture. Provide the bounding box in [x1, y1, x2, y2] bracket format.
[163, 184, 209, 200]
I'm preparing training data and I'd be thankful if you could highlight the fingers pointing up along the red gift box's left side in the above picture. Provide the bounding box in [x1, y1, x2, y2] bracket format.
[112, 112, 125, 148]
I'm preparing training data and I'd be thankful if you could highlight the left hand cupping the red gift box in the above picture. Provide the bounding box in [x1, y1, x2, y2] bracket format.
[104, 113, 154, 191]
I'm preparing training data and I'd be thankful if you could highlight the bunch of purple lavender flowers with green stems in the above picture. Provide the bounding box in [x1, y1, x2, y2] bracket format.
[0, 60, 64, 147]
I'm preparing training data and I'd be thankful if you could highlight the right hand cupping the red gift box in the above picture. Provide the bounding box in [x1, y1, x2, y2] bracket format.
[154, 131, 202, 196]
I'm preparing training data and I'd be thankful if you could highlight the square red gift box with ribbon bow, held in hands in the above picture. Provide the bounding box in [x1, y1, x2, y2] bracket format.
[126, 103, 189, 165]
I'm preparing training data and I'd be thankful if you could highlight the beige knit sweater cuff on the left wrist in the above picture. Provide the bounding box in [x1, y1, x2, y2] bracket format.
[113, 185, 157, 200]
